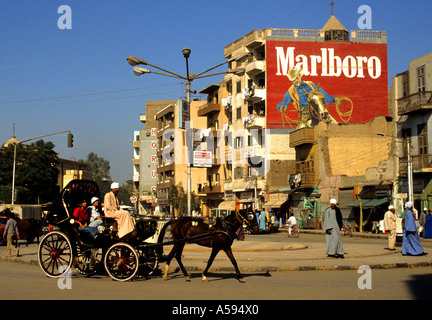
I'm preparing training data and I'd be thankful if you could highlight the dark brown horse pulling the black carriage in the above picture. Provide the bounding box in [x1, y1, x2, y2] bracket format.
[163, 210, 258, 282]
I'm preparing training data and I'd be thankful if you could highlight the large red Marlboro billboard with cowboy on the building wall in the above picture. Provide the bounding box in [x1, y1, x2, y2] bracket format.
[266, 40, 388, 129]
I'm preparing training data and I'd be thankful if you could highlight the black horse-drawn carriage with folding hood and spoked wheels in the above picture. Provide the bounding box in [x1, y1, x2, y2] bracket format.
[38, 180, 161, 281]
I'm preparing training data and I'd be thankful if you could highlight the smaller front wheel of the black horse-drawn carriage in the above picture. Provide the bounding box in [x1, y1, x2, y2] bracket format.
[105, 243, 139, 281]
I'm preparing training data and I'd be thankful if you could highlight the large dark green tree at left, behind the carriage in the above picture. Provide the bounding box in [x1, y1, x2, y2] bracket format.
[0, 140, 59, 204]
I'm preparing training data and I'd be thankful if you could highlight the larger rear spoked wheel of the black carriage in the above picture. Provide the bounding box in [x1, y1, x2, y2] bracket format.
[38, 231, 73, 278]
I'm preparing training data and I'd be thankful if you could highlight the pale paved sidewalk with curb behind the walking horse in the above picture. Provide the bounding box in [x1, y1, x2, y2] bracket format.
[0, 230, 432, 272]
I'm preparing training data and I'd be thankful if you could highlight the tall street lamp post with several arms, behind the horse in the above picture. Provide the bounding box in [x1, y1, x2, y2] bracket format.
[126, 48, 241, 216]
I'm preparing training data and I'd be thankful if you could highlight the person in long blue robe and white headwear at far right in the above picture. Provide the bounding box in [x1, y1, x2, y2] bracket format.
[402, 201, 426, 256]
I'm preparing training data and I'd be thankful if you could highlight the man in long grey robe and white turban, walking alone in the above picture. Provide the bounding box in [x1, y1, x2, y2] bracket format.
[323, 199, 344, 259]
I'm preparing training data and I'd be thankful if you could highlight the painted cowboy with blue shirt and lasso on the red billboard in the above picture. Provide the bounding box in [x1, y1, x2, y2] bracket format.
[277, 67, 353, 129]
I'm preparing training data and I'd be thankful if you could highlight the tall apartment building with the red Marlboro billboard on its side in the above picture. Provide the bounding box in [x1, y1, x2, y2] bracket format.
[219, 10, 391, 228]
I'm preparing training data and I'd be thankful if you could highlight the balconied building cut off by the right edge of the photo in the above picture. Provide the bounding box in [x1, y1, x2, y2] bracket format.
[391, 53, 432, 211]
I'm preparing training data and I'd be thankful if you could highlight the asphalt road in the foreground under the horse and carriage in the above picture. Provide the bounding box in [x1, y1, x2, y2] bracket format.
[0, 263, 432, 301]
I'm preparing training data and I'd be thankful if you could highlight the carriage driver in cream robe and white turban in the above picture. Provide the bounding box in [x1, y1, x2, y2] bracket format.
[104, 182, 135, 239]
